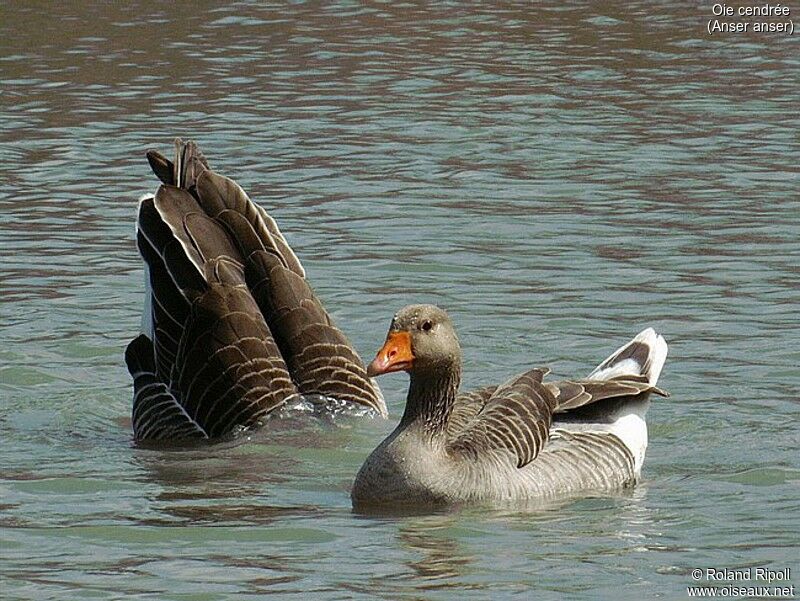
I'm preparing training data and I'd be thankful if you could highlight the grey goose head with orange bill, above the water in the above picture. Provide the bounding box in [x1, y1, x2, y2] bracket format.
[367, 305, 461, 377]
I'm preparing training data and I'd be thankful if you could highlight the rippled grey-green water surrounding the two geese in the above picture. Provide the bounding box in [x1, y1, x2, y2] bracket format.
[0, 2, 800, 599]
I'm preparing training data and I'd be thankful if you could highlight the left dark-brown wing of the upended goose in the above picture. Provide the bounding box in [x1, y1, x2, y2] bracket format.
[129, 170, 297, 440]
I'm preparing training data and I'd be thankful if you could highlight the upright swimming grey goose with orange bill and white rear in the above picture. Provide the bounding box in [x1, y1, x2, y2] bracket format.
[352, 305, 667, 508]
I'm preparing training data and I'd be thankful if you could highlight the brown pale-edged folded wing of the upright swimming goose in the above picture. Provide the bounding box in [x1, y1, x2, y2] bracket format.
[448, 369, 556, 467]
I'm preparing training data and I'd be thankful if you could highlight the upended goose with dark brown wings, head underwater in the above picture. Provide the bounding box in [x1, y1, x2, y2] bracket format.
[125, 140, 386, 441]
